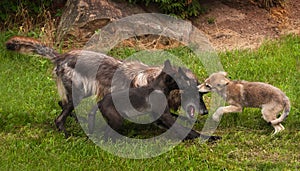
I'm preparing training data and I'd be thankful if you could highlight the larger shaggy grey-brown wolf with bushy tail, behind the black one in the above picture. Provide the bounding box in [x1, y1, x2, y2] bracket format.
[6, 36, 211, 137]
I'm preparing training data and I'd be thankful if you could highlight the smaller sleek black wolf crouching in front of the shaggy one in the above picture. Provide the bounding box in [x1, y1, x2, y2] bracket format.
[98, 60, 219, 140]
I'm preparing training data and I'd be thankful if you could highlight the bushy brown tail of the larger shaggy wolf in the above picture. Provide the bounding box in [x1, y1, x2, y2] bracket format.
[6, 36, 59, 61]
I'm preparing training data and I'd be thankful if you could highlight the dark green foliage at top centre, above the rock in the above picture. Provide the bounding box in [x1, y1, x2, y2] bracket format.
[128, 0, 203, 18]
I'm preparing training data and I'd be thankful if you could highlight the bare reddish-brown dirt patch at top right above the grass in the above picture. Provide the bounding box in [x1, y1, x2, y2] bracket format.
[191, 0, 300, 51]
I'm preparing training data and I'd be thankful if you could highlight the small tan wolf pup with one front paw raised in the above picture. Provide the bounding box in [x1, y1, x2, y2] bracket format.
[198, 72, 291, 134]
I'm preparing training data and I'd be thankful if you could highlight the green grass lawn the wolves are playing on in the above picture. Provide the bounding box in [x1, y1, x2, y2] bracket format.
[0, 34, 300, 170]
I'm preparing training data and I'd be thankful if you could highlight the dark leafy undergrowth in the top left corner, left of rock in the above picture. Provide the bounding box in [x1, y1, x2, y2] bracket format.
[0, 0, 63, 34]
